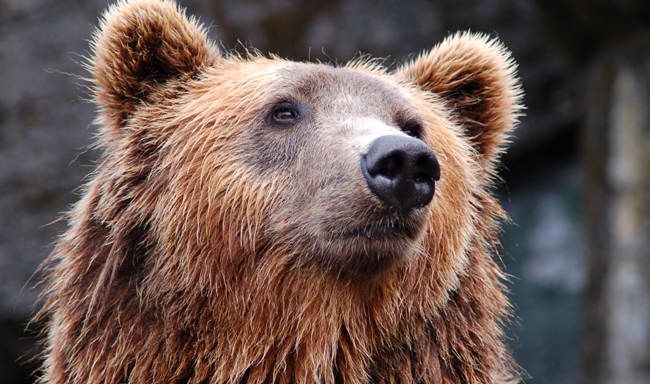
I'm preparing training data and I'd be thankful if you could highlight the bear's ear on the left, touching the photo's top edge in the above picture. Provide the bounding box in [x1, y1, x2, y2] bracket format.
[88, 0, 219, 127]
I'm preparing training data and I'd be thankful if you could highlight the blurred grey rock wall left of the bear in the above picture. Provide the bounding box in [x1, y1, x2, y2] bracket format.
[0, 1, 99, 383]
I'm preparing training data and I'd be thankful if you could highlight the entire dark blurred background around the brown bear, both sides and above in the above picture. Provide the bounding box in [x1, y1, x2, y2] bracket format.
[0, 0, 650, 384]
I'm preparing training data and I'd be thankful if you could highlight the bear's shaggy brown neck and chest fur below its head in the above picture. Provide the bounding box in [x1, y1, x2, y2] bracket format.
[43, 190, 512, 384]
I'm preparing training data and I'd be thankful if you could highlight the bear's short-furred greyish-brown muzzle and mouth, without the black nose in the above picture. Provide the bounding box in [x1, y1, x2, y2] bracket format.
[272, 121, 430, 275]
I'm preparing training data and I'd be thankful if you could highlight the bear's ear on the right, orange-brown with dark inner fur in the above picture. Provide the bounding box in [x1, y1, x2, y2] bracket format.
[396, 32, 523, 173]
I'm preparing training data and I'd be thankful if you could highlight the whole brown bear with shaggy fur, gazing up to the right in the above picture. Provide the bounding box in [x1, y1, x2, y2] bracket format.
[35, 0, 521, 384]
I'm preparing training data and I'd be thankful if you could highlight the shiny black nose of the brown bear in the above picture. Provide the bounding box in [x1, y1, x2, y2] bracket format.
[361, 136, 440, 212]
